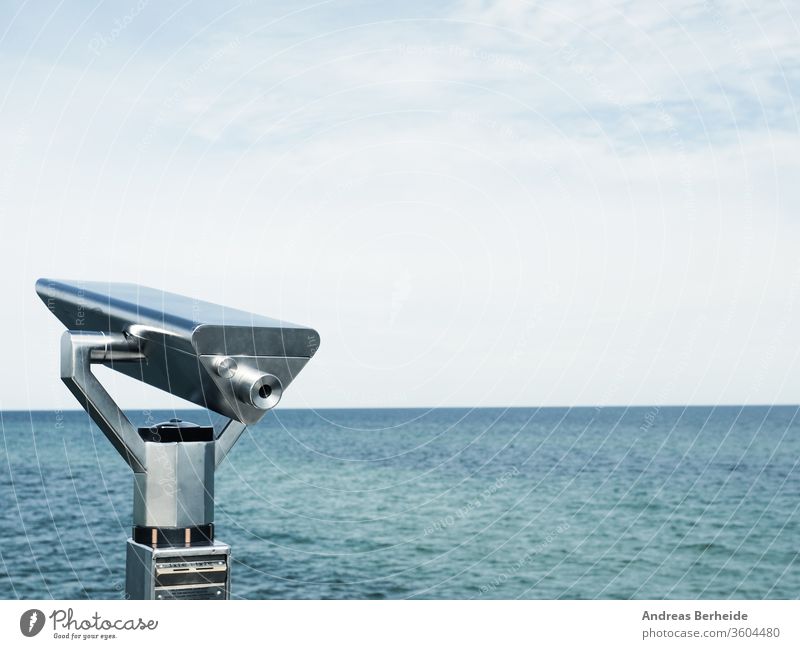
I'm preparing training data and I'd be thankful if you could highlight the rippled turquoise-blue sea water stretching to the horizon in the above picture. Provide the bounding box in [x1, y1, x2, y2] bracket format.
[0, 407, 800, 598]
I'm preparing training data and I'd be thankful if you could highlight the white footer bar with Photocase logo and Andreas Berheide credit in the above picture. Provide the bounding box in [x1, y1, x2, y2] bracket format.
[0, 601, 800, 649]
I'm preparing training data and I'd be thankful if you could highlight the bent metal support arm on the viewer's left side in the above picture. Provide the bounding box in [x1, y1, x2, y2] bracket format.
[61, 331, 147, 473]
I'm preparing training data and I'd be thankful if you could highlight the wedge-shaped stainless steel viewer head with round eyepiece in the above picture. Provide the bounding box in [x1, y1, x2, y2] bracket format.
[36, 279, 319, 424]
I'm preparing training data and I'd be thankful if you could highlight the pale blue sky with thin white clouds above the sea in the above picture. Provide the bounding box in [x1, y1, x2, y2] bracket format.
[0, 0, 800, 409]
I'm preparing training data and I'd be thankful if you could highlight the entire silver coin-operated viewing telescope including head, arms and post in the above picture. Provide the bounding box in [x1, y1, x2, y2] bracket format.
[36, 279, 319, 599]
